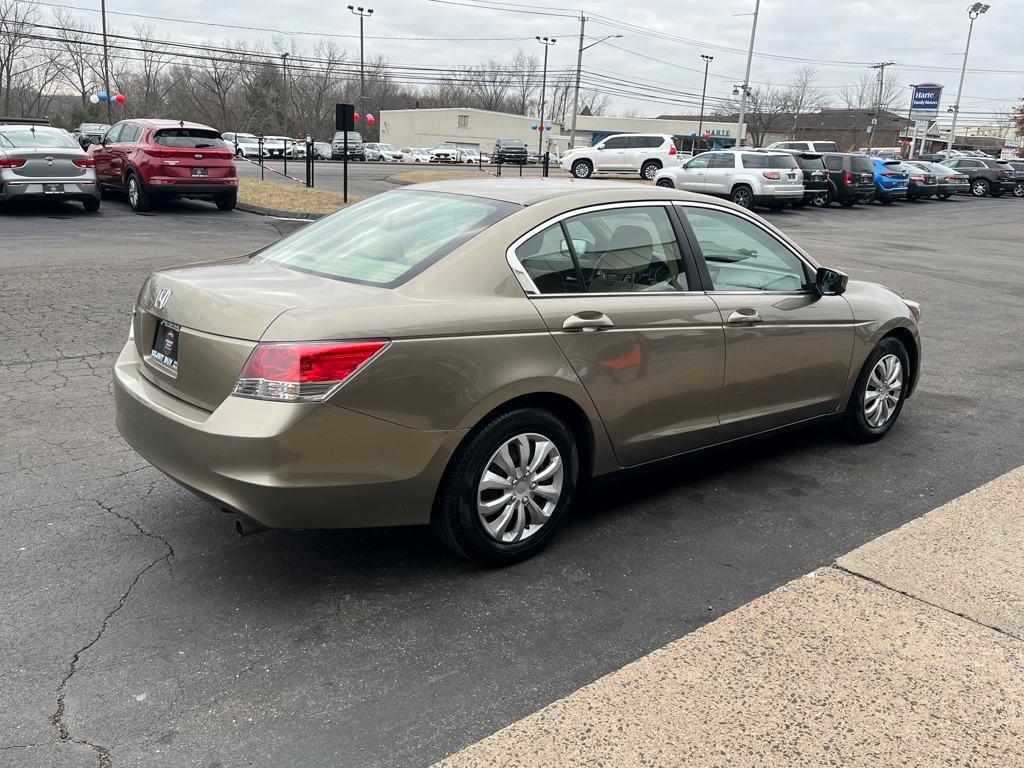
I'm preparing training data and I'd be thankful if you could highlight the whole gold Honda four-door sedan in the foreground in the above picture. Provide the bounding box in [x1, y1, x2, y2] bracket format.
[114, 179, 921, 564]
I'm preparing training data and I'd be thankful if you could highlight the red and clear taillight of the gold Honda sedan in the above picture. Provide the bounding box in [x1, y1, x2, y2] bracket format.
[231, 340, 388, 401]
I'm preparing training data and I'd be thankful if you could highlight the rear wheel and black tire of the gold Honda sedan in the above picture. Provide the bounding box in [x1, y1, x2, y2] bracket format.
[430, 408, 580, 566]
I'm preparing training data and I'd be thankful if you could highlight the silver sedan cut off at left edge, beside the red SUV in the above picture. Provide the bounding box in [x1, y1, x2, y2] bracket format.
[0, 125, 99, 212]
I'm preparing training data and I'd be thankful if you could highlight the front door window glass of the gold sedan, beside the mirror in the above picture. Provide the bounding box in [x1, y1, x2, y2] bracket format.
[684, 208, 808, 292]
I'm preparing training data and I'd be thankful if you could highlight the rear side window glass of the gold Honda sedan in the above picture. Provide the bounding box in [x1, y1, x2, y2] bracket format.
[516, 206, 690, 293]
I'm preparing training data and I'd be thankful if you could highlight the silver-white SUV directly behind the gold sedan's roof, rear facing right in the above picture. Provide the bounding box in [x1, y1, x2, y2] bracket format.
[654, 150, 804, 209]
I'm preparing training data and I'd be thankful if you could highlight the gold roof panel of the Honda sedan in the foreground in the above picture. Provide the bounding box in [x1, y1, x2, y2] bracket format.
[407, 178, 709, 208]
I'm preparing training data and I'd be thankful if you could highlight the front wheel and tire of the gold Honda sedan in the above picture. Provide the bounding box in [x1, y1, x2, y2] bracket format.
[844, 337, 910, 442]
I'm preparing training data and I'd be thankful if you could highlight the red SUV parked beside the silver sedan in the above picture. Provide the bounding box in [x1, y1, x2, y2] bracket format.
[90, 120, 239, 211]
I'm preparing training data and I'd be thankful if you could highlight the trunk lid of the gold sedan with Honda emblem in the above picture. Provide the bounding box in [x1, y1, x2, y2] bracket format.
[133, 257, 386, 411]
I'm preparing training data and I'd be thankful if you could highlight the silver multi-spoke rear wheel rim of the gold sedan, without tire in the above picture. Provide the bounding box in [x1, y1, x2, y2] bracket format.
[476, 432, 564, 544]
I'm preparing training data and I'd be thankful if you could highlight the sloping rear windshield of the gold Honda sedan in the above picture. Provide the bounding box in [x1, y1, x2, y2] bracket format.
[254, 190, 519, 288]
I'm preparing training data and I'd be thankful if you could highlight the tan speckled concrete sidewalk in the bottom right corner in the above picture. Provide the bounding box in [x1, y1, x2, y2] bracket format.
[438, 468, 1024, 768]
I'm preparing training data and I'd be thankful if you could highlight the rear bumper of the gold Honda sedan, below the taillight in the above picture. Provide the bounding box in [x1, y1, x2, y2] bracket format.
[114, 342, 463, 528]
